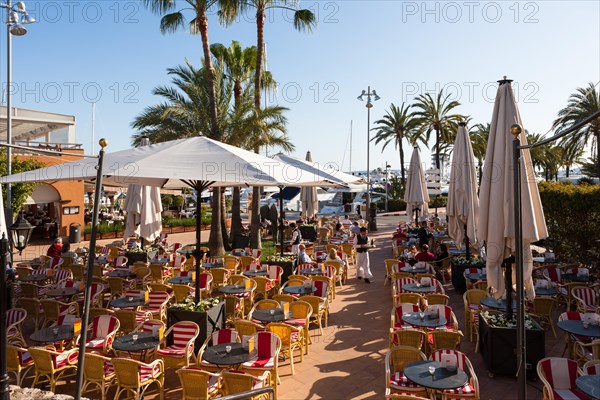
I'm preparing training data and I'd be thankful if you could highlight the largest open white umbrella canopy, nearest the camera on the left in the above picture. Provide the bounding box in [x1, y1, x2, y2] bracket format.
[0, 136, 339, 189]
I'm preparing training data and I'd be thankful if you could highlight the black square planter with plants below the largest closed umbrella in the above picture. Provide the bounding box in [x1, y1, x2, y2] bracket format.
[479, 311, 546, 377]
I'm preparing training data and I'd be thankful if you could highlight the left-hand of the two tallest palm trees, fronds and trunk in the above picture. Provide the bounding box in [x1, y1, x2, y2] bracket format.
[143, 0, 230, 255]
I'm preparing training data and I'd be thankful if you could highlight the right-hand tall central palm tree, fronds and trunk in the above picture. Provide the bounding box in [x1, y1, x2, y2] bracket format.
[220, 0, 316, 248]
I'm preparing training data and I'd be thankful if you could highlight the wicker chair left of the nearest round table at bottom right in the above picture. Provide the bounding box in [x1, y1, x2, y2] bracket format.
[385, 346, 427, 396]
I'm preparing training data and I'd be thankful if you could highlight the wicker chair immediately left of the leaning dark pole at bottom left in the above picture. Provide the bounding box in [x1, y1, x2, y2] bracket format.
[29, 347, 79, 392]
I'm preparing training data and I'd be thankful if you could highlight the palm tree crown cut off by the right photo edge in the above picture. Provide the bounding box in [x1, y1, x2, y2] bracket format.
[553, 82, 600, 175]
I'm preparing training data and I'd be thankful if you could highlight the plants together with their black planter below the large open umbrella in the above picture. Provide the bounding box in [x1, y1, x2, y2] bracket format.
[167, 296, 225, 351]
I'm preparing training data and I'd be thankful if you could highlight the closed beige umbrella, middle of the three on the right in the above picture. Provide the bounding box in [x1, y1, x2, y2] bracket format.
[446, 124, 479, 252]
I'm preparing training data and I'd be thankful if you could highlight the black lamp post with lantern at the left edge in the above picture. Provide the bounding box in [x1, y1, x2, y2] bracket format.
[0, 215, 33, 400]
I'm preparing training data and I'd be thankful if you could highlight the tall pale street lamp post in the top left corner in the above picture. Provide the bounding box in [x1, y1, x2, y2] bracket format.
[0, 0, 35, 225]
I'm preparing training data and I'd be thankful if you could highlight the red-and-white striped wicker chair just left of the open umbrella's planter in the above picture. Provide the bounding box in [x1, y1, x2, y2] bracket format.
[156, 321, 200, 369]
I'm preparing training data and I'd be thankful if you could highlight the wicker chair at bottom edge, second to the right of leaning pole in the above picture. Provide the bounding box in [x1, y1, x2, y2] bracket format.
[112, 357, 165, 400]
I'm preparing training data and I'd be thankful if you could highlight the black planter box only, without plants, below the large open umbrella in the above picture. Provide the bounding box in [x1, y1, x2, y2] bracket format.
[167, 302, 225, 352]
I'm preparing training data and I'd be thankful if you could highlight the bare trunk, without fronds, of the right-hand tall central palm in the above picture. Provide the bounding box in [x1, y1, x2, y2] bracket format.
[250, 7, 265, 249]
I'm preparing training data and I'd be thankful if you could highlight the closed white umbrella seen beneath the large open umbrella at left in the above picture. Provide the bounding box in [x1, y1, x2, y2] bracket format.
[124, 139, 162, 241]
